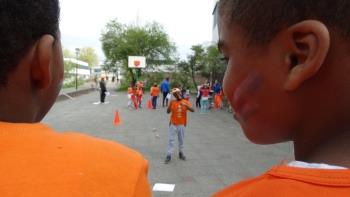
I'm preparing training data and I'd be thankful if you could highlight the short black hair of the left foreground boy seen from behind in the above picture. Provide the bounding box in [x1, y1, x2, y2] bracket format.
[0, 0, 60, 87]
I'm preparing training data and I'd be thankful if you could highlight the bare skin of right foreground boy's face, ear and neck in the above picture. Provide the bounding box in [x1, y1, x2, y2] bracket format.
[219, 17, 350, 168]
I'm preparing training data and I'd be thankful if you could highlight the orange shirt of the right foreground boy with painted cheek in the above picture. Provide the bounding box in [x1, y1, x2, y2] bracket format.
[213, 165, 350, 197]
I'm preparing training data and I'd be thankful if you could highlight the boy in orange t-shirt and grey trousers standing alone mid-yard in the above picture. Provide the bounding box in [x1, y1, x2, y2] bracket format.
[165, 88, 194, 164]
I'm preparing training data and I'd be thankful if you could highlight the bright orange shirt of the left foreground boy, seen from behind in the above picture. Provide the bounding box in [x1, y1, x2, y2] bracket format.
[0, 122, 151, 197]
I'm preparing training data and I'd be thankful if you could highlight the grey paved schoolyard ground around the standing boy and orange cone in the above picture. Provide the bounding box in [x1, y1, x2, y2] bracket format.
[43, 92, 292, 197]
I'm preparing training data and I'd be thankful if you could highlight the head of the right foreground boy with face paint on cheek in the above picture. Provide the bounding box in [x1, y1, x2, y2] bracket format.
[219, 0, 350, 144]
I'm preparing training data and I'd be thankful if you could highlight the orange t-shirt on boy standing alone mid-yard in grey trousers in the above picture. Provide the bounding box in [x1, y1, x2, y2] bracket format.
[170, 99, 192, 125]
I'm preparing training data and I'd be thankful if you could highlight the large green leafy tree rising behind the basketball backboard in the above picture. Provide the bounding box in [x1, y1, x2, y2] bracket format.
[101, 20, 176, 82]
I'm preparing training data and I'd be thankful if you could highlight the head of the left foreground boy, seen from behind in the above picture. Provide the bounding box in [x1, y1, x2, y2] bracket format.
[0, 0, 63, 122]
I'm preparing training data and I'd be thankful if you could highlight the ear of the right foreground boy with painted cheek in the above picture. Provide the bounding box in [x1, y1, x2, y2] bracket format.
[284, 20, 330, 91]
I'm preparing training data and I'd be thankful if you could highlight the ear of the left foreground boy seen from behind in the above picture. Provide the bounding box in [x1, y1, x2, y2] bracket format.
[31, 35, 55, 89]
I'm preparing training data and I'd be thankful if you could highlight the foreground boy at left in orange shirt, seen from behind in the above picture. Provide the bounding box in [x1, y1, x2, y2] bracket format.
[0, 0, 151, 197]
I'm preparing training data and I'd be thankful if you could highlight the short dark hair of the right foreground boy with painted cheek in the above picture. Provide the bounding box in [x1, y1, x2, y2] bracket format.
[219, 0, 350, 44]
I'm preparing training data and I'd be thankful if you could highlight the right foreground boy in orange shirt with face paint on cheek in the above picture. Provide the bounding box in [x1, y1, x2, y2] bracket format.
[215, 0, 350, 197]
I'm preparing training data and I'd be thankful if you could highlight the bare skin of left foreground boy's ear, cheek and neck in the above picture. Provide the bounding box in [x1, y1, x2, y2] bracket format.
[0, 35, 63, 123]
